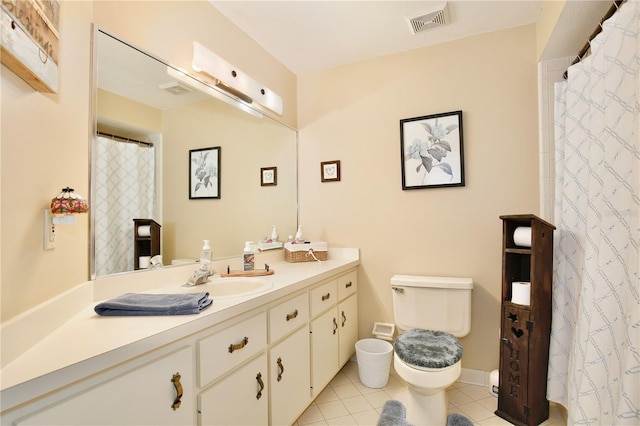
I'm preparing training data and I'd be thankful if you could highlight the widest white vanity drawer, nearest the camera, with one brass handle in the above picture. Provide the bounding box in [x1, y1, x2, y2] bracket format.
[198, 312, 267, 387]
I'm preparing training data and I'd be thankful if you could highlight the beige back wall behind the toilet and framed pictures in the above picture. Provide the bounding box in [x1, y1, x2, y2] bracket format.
[298, 25, 538, 371]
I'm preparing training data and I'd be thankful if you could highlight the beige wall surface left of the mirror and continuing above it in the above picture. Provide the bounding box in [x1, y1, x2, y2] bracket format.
[0, 0, 297, 321]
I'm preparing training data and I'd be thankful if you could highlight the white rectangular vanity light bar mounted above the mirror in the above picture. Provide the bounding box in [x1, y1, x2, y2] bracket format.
[191, 41, 282, 115]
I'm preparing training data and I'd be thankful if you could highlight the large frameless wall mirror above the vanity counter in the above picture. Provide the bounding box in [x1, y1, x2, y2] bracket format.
[89, 30, 298, 279]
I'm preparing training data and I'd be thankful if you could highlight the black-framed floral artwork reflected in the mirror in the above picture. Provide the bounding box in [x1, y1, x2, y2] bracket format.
[189, 146, 220, 199]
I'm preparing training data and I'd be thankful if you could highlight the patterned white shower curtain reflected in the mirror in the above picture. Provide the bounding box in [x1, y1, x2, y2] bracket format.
[91, 136, 156, 276]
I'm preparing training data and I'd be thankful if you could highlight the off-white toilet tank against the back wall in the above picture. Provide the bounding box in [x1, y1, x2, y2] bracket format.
[391, 275, 473, 337]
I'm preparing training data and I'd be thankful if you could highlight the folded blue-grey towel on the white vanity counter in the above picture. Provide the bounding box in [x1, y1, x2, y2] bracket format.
[94, 292, 213, 316]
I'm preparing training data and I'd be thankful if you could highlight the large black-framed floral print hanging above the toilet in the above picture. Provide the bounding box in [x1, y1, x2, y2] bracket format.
[400, 111, 464, 190]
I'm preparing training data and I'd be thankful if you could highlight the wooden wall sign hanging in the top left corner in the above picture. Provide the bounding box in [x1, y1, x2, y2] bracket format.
[0, 0, 60, 93]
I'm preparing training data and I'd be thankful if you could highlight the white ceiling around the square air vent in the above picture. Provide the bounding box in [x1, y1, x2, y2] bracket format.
[210, 0, 542, 75]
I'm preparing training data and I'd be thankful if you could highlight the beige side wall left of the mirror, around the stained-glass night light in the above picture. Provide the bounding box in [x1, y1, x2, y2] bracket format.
[0, 2, 93, 321]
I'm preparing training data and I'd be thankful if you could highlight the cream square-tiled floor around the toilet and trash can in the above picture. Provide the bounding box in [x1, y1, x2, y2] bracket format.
[294, 361, 566, 426]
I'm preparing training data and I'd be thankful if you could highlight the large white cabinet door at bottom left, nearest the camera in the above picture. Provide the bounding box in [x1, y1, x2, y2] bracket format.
[16, 347, 196, 425]
